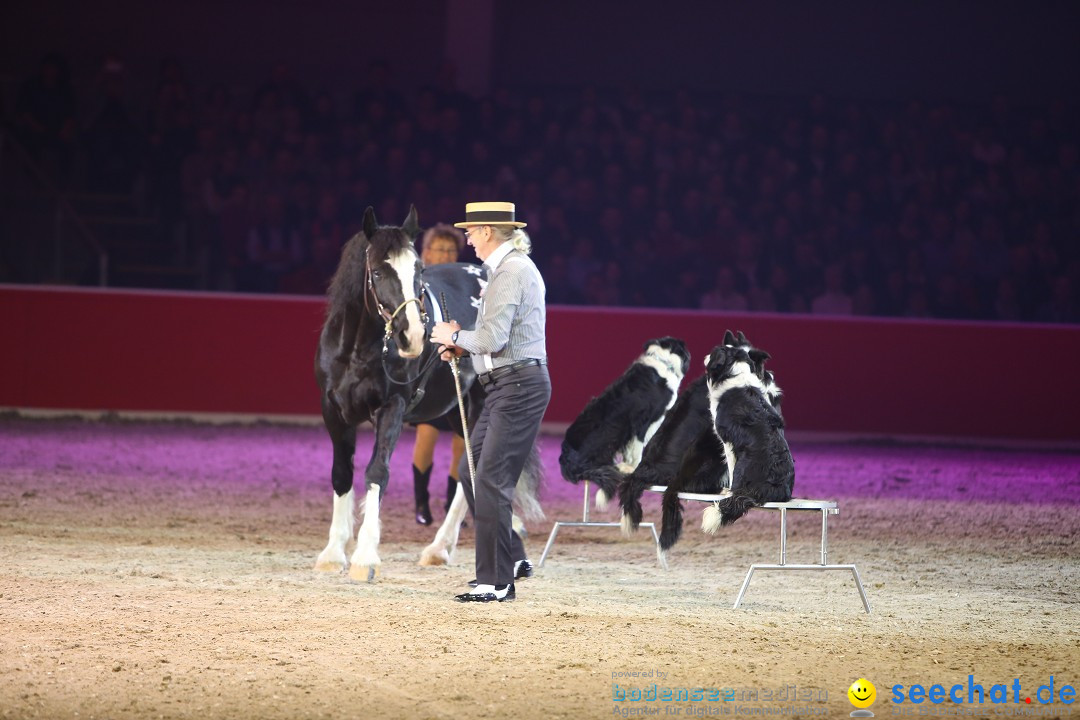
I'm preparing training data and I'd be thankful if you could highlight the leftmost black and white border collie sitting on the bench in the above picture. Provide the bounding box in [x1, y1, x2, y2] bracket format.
[558, 337, 690, 510]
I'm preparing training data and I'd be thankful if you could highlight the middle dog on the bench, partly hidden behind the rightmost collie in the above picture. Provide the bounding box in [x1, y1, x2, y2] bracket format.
[619, 330, 781, 537]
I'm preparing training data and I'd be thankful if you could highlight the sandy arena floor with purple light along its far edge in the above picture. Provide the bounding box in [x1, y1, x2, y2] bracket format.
[0, 418, 1080, 718]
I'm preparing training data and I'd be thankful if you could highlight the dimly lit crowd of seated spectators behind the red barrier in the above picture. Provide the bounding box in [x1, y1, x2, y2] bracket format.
[6, 55, 1080, 323]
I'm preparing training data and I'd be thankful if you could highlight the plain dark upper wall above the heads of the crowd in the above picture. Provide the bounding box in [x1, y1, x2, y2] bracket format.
[8, 0, 1080, 103]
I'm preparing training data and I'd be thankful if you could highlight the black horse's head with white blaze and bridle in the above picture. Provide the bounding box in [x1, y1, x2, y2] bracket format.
[364, 207, 424, 357]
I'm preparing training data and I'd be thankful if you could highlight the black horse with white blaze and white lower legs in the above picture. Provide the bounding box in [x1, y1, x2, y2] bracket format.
[315, 207, 520, 581]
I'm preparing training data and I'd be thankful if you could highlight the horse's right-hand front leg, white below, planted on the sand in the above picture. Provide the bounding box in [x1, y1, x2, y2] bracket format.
[349, 395, 405, 582]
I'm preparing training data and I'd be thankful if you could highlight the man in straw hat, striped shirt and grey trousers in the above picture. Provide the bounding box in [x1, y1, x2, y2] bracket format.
[431, 203, 551, 602]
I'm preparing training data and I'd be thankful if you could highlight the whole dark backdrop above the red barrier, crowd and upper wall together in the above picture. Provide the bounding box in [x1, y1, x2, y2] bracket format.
[0, 0, 1080, 323]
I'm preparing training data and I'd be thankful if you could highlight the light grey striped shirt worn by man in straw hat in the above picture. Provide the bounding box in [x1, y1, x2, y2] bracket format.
[456, 242, 548, 372]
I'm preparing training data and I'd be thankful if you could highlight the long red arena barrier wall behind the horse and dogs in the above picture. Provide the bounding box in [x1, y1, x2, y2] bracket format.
[0, 285, 1080, 443]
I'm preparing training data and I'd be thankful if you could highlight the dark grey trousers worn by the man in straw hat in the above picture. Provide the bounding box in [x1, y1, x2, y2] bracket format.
[458, 365, 551, 585]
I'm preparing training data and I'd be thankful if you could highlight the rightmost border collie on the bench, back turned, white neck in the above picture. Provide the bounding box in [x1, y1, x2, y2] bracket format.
[701, 345, 795, 532]
